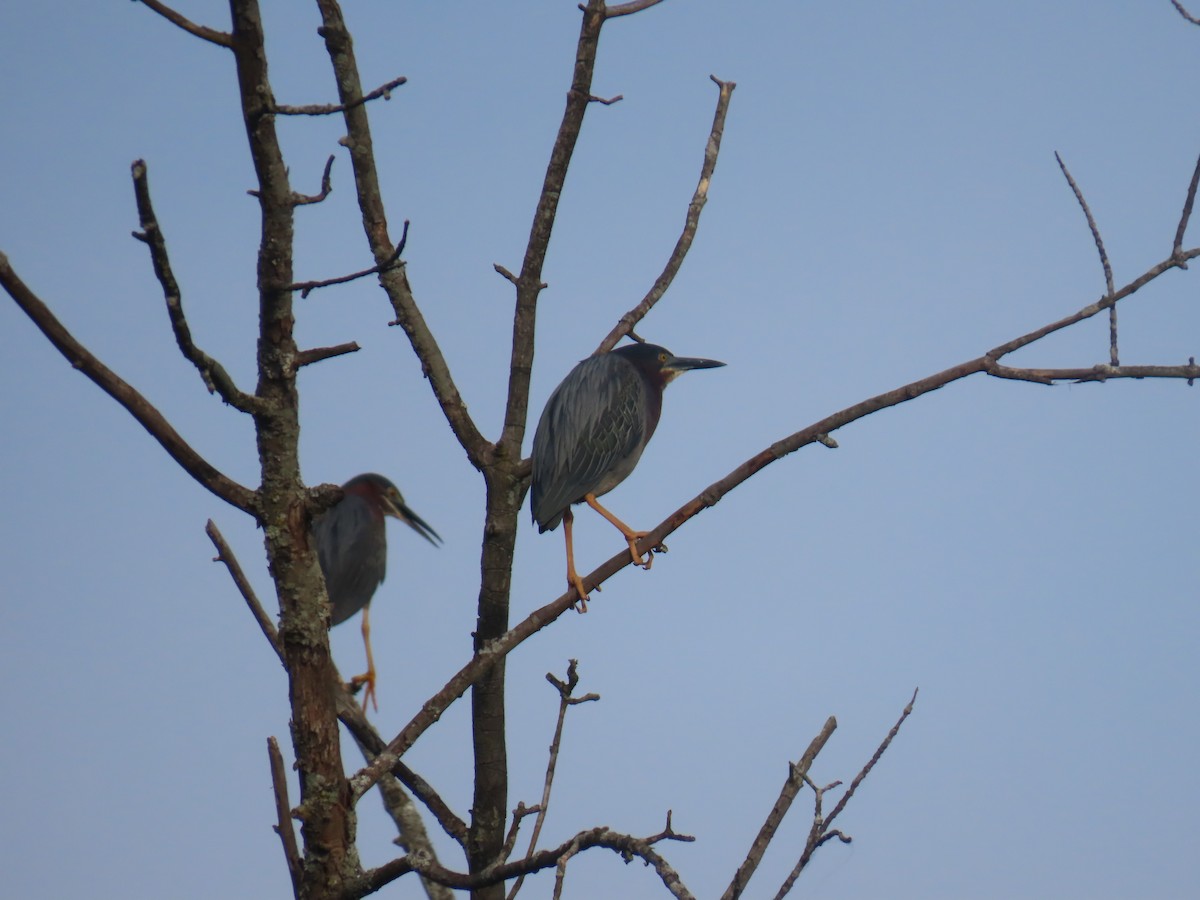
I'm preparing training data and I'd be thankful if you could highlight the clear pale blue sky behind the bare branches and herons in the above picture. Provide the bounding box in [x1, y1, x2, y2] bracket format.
[0, 0, 1200, 898]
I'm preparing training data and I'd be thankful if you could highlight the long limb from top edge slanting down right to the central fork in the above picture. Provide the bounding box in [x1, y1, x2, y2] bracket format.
[317, 0, 491, 468]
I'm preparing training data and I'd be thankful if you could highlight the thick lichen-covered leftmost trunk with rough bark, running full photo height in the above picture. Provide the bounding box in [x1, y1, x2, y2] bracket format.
[230, 0, 360, 898]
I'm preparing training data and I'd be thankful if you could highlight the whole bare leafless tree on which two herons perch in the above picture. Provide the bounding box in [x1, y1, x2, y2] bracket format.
[0, 0, 1200, 900]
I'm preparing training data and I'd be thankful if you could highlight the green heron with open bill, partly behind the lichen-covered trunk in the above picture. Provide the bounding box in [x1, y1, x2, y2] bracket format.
[312, 474, 442, 709]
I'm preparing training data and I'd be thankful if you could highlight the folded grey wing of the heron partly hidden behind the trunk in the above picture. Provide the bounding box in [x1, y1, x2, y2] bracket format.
[312, 494, 388, 625]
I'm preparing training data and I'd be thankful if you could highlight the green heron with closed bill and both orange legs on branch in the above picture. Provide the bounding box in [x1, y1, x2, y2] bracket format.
[530, 342, 725, 611]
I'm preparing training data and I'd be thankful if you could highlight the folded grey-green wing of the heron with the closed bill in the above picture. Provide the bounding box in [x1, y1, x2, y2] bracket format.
[532, 354, 647, 532]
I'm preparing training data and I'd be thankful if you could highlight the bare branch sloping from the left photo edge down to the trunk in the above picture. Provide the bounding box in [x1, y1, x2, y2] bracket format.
[0, 253, 258, 516]
